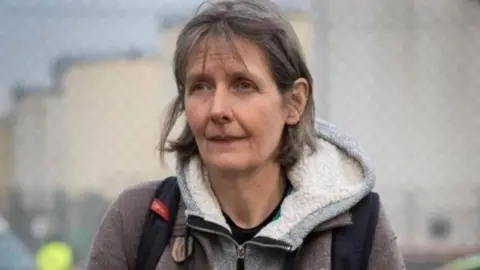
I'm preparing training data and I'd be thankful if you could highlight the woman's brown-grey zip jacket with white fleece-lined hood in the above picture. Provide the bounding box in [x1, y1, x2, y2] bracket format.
[87, 121, 405, 270]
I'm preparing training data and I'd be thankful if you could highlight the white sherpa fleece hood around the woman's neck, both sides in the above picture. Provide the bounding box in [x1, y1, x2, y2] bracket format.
[177, 120, 375, 249]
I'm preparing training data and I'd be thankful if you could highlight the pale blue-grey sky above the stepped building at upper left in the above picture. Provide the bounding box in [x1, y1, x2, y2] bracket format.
[0, 0, 308, 113]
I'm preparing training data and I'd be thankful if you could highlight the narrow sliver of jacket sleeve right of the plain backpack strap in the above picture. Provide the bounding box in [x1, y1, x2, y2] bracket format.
[368, 204, 406, 270]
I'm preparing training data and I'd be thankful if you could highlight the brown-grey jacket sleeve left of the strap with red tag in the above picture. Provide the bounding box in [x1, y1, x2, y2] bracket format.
[87, 184, 155, 270]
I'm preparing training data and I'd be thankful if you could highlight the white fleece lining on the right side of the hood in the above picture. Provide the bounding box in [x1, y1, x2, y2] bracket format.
[259, 140, 365, 240]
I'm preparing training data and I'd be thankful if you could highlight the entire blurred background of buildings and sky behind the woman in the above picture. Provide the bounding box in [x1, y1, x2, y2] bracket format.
[0, 0, 480, 269]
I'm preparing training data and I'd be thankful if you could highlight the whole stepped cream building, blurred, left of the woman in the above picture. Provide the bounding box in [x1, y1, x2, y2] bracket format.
[11, 53, 182, 252]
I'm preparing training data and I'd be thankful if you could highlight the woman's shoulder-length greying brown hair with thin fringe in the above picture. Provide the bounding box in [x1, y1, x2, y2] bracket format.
[159, 0, 317, 169]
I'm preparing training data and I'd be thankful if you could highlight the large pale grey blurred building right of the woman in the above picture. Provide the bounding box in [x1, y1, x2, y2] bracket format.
[311, 0, 480, 247]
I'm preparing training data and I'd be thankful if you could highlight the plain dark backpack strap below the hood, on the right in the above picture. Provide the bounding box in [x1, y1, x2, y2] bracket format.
[332, 192, 380, 270]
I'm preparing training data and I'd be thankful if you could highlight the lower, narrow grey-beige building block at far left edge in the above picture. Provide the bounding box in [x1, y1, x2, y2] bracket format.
[11, 85, 57, 209]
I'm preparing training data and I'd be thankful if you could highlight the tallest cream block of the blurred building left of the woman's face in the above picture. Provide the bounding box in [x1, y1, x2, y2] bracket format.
[50, 55, 176, 198]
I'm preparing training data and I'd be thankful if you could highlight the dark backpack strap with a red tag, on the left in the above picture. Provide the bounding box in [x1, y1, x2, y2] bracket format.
[135, 177, 180, 270]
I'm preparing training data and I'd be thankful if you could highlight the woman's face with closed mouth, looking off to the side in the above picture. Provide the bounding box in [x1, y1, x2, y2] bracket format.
[185, 38, 299, 171]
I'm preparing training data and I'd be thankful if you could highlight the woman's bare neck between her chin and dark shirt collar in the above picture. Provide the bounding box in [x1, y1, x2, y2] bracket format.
[208, 164, 287, 229]
